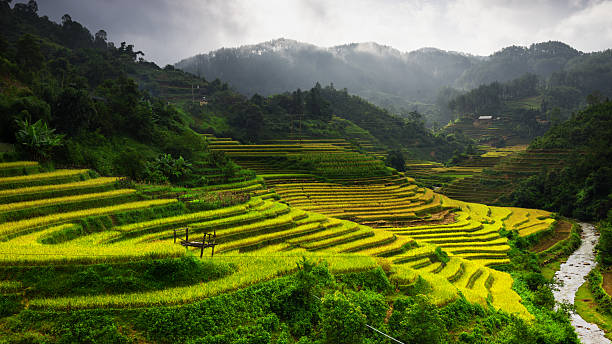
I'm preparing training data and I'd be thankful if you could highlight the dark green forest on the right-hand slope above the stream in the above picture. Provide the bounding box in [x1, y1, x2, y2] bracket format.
[512, 99, 612, 220]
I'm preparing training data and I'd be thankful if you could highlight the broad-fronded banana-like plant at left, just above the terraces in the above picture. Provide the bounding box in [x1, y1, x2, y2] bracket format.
[15, 119, 64, 160]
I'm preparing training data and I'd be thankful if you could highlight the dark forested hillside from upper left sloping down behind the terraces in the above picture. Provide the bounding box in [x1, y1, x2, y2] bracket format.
[0, 1, 466, 169]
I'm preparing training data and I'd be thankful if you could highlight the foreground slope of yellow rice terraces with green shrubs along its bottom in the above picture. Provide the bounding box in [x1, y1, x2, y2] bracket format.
[0, 155, 572, 343]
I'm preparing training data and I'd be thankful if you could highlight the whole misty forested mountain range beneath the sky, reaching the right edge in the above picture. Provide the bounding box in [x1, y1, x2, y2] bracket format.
[175, 39, 612, 125]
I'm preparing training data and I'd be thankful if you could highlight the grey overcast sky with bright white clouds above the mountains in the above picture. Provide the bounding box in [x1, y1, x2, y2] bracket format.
[27, 0, 612, 66]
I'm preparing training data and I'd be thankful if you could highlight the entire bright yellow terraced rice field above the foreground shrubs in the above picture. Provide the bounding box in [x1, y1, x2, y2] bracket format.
[0, 161, 549, 318]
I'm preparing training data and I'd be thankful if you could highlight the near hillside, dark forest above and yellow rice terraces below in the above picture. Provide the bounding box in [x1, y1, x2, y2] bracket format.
[0, 0, 592, 344]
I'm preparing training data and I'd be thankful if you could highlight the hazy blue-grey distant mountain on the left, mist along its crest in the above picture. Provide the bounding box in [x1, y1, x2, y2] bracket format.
[175, 39, 481, 118]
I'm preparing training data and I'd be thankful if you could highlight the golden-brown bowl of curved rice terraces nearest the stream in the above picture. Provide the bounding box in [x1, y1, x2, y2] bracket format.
[264, 174, 554, 265]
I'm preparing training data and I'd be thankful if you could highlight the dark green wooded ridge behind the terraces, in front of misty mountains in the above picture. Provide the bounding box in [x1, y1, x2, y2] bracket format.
[130, 64, 470, 161]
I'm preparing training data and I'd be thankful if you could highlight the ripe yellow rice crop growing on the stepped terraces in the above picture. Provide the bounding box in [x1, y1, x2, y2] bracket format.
[0, 164, 545, 320]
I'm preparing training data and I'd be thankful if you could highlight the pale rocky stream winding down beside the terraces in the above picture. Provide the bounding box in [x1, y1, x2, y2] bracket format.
[553, 223, 612, 344]
